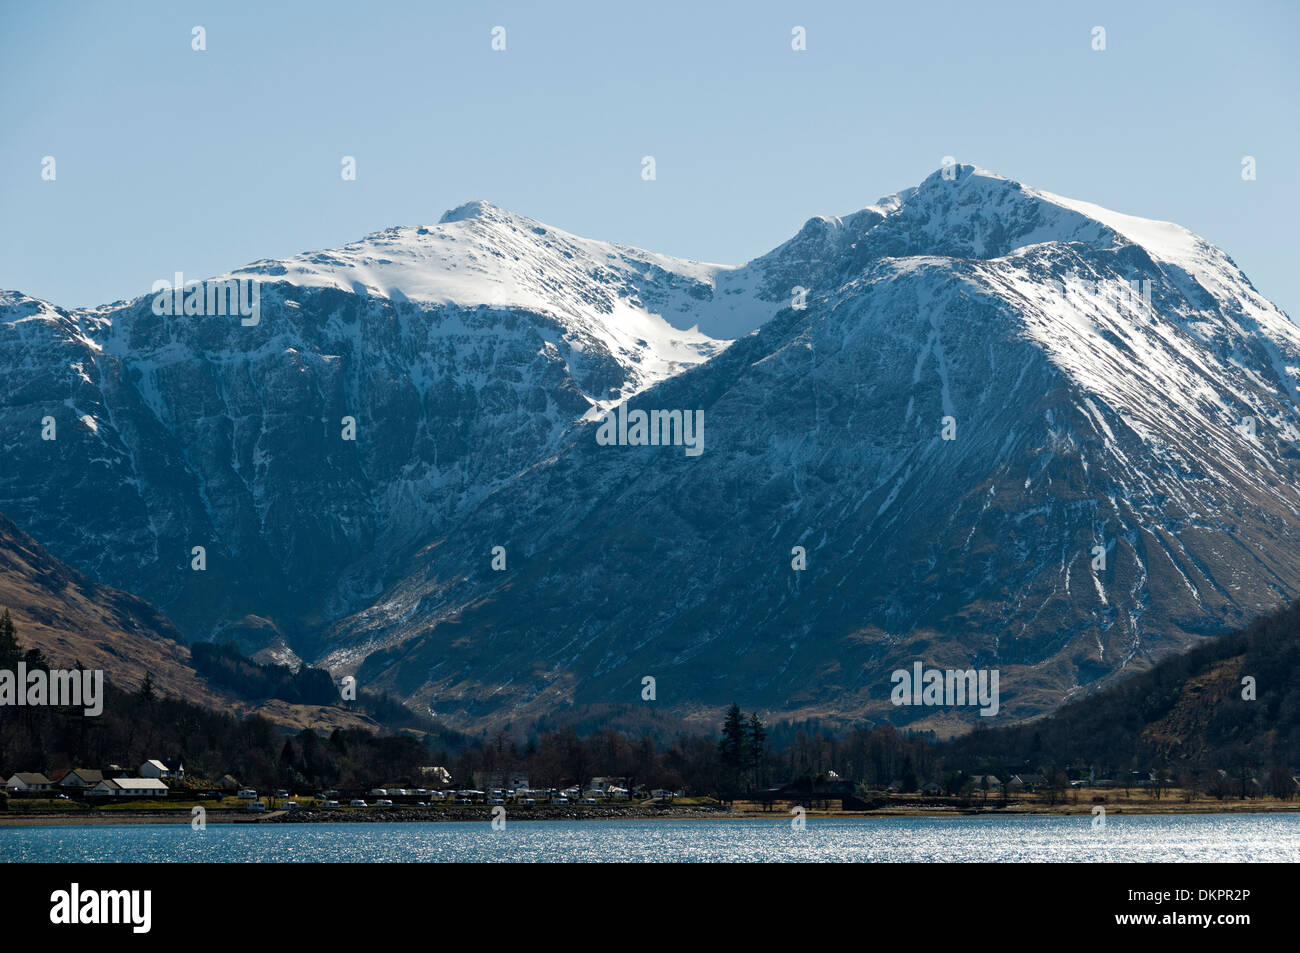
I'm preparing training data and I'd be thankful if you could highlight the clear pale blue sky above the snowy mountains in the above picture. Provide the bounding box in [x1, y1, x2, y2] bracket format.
[0, 0, 1300, 320]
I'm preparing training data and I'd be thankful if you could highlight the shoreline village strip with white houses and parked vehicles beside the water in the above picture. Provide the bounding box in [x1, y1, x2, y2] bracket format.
[0, 758, 1300, 820]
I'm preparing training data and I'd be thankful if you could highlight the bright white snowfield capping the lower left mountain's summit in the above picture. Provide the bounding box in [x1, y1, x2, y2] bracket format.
[233, 202, 788, 345]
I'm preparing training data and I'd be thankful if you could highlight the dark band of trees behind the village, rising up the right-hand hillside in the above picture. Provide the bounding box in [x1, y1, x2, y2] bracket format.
[0, 603, 1300, 798]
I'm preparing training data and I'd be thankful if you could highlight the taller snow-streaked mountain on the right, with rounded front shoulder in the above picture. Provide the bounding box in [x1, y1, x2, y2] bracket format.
[319, 166, 1300, 728]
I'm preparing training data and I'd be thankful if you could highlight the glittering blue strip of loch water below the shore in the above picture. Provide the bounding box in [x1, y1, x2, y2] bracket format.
[0, 814, 1300, 863]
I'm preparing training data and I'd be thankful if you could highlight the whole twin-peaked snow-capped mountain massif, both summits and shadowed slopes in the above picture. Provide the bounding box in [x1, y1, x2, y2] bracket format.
[0, 166, 1300, 729]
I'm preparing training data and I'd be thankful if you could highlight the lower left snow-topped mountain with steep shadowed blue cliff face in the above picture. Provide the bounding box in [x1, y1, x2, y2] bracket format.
[0, 202, 784, 641]
